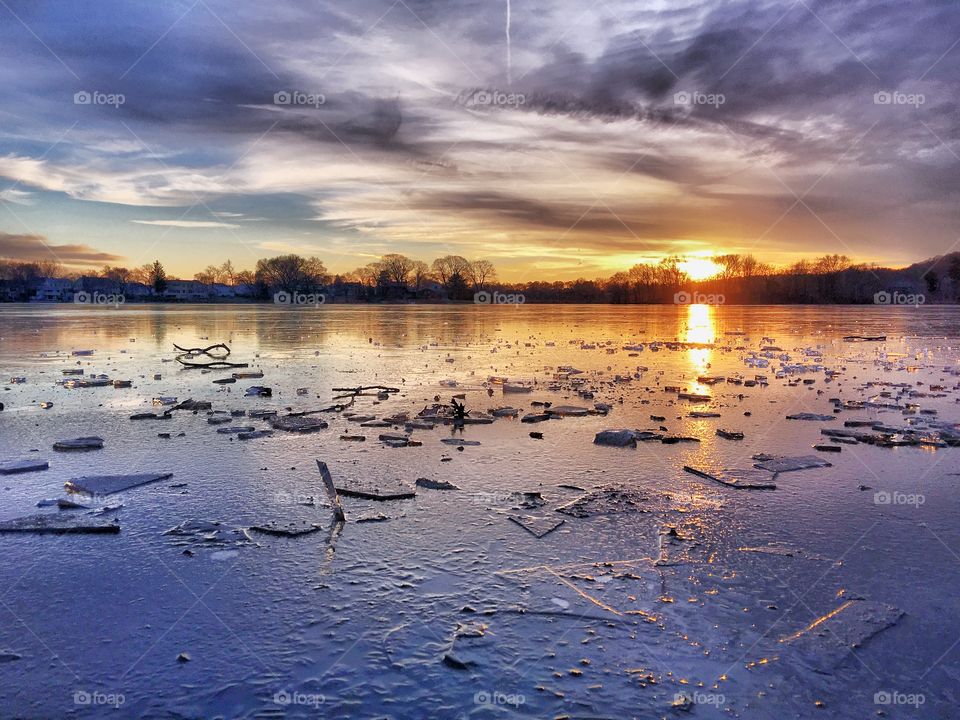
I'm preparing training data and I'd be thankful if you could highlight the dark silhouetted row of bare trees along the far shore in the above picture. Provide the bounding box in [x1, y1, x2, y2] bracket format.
[0, 253, 960, 304]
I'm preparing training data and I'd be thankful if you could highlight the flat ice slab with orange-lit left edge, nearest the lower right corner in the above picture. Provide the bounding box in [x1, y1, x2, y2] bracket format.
[780, 599, 904, 673]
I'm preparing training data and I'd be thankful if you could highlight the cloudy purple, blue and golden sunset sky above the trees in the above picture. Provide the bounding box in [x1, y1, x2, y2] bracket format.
[0, 0, 960, 281]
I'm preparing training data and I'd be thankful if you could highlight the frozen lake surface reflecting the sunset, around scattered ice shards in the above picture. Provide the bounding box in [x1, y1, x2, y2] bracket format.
[0, 305, 960, 719]
